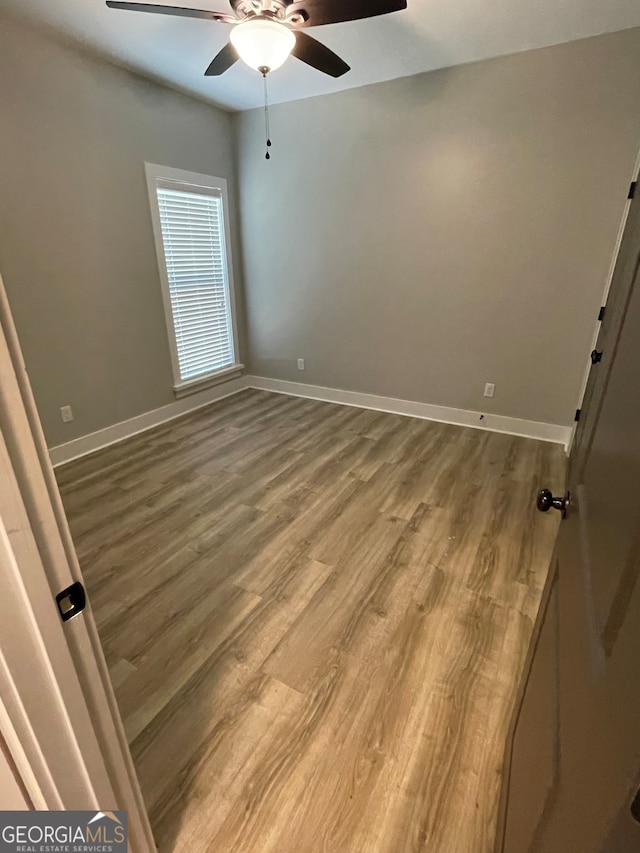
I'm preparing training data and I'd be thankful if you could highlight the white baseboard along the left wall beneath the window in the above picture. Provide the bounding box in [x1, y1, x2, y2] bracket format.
[49, 376, 249, 468]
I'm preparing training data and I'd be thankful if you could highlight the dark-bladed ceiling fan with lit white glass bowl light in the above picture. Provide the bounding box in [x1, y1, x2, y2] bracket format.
[107, 0, 407, 77]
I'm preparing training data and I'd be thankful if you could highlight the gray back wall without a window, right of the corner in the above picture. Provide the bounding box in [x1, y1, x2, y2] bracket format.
[234, 29, 640, 424]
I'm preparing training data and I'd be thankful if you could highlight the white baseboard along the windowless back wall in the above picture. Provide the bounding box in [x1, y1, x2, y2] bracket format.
[246, 376, 572, 450]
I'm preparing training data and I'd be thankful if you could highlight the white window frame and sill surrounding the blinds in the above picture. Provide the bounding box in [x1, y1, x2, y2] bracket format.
[145, 163, 244, 397]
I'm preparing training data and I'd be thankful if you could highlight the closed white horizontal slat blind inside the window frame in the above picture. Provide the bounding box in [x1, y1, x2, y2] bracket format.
[156, 188, 235, 381]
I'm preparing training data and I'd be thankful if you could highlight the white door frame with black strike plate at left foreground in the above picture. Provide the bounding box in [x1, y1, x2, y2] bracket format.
[0, 277, 156, 853]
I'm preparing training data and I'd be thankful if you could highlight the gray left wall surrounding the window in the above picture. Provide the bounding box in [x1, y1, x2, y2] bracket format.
[0, 22, 242, 445]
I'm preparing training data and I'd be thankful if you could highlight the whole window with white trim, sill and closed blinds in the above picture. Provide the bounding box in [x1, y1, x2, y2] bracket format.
[146, 163, 242, 396]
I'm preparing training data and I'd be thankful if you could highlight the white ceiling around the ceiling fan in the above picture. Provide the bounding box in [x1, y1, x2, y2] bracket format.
[0, 0, 640, 110]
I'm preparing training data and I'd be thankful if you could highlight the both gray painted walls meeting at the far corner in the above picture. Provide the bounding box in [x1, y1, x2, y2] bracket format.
[0, 22, 640, 445]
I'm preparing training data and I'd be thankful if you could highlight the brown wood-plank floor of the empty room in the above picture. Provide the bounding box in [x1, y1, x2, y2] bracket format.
[57, 391, 564, 853]
